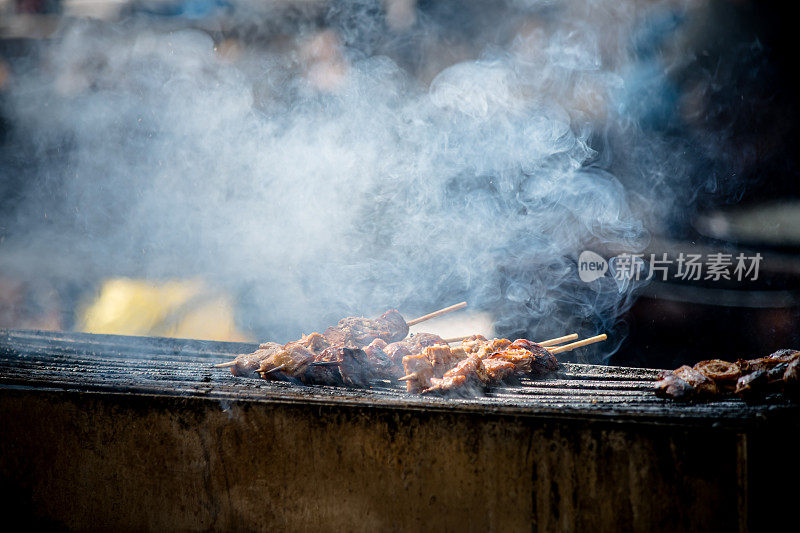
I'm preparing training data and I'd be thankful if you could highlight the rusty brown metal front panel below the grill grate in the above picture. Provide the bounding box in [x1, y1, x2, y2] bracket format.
[0, 389, 740, 531]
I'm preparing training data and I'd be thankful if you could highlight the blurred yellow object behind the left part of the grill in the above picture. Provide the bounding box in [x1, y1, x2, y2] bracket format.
[78, 278, 253, 341]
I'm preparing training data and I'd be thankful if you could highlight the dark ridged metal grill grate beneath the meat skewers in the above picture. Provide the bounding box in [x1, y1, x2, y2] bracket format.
[0, 330, 799, 427]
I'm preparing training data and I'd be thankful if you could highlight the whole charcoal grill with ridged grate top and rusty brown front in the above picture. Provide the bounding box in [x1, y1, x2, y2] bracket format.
[0, 331, 800, 531]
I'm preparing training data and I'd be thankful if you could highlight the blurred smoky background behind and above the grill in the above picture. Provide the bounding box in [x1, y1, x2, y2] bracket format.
[0, 0, 800, 367]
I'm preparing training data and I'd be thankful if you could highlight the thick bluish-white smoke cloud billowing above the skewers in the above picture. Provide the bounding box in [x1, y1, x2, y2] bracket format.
[0, 1, 724, 357]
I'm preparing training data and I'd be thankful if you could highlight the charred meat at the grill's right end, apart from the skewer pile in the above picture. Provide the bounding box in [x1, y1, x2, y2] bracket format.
[655, 350, 800, 401]
